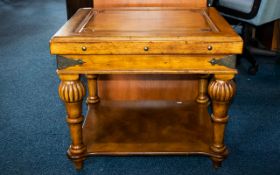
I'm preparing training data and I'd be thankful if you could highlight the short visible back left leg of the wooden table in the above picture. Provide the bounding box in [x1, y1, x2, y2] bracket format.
[86, 74, 99, 104]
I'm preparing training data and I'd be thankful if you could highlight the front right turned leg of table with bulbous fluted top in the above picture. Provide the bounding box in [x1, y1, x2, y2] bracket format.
[208, 75, 236, 168]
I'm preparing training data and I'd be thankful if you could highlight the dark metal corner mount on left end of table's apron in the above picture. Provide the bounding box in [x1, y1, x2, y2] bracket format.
[56, 55, 85, 70]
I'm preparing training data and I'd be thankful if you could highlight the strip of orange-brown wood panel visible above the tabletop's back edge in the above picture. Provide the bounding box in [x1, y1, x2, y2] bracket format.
[93, 0, 206, 8]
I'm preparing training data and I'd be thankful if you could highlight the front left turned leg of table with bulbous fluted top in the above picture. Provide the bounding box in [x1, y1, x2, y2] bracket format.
[58, 75, 86, 169]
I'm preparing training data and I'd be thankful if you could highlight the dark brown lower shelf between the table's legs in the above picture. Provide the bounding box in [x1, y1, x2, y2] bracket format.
[83, 101, 214, 156]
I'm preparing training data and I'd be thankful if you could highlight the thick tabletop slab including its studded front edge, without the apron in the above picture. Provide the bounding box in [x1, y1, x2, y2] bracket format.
[50, 8, 243, 55]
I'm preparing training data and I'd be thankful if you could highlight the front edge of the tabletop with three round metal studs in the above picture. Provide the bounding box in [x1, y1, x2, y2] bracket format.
[51, 41, 243, 55]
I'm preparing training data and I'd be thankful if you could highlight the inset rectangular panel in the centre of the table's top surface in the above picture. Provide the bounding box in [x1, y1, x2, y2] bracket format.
[79, 9, 218, 37]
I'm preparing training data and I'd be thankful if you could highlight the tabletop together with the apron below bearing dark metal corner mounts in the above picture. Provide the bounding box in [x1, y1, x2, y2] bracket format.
[50, 7, 243, 74]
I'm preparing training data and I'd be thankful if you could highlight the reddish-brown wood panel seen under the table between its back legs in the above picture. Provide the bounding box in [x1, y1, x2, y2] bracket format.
[98, 74, 198, 101]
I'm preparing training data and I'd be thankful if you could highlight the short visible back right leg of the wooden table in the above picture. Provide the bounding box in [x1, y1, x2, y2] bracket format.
[196, 75, 209, 104]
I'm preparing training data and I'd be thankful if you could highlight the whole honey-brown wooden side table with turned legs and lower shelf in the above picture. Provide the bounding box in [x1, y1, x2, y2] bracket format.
[50, 7, 243, 169]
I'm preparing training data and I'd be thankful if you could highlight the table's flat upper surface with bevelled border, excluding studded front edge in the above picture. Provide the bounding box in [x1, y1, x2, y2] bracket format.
[52, 7, 241, 42]
